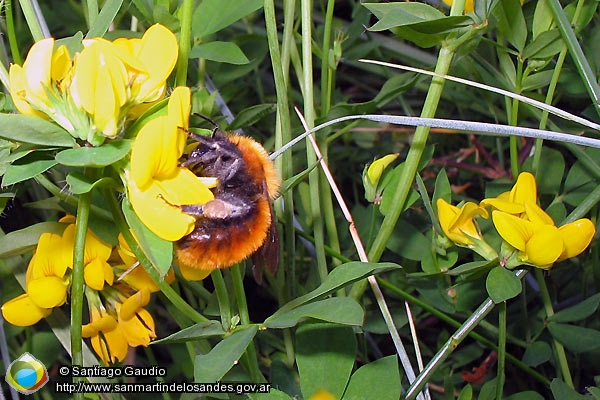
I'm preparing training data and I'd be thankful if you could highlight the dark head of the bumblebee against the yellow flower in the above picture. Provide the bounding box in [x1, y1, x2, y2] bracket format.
[183, 131, 245, 184]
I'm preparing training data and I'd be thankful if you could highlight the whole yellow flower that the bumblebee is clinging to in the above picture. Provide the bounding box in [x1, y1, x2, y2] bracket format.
[126, 87, 214, 241]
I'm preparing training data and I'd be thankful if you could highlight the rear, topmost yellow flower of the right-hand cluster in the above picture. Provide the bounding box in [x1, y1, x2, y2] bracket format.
[480, 172, 537, 215]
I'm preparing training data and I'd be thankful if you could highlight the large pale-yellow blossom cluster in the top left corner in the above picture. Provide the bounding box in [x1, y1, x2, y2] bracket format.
[9, 24, 178, 146]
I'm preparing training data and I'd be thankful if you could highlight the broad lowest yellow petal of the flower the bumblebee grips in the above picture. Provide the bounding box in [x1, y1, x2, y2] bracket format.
[128, 182, 196, 242]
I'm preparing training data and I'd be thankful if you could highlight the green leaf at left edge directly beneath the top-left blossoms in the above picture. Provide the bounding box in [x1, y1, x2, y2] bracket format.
[0, 113, 75, 147]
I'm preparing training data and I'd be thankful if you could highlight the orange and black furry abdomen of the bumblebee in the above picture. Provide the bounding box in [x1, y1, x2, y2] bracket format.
[175, 198, 271, 270]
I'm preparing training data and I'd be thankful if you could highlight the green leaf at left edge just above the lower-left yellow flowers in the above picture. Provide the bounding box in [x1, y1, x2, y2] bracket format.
[0, 221, 67, 258]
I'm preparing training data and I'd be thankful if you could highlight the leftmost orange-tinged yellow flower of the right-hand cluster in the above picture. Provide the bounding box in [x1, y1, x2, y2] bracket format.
[437, 199, 488, 246]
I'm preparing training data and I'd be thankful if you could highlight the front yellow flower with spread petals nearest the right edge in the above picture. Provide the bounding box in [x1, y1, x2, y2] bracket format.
[492, 204, 596, 269]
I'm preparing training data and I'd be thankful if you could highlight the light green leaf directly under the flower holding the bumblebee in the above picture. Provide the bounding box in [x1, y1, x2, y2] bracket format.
[121, 198, 173, 276]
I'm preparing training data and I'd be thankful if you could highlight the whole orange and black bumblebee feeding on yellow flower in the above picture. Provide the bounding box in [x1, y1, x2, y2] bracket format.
[175, 129, 281, 283]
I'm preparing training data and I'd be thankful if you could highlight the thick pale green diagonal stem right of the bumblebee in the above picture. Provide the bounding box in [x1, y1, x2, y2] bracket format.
[350, 43, 454, 299]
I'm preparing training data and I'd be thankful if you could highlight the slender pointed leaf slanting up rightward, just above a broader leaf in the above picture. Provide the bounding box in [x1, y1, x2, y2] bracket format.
[270, 261, 402, 318]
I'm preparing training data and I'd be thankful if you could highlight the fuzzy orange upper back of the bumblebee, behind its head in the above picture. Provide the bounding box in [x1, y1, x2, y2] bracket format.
[228, 135, 281, 200]
